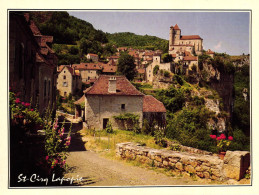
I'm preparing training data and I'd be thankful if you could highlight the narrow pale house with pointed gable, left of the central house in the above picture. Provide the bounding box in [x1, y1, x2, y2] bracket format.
[57, 65, 82, 97]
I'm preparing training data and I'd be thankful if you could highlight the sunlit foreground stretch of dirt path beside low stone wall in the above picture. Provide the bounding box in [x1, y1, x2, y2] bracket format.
[65, 151, 218, 186]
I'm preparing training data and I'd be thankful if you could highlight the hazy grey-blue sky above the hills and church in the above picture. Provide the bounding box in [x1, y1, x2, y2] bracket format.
[69, 10, 250, 55]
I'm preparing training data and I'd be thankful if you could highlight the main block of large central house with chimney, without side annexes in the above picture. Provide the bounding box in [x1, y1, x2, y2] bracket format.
[84, 75, 144, 129]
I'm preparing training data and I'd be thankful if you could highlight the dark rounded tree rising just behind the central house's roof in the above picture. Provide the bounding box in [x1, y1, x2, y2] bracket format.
[117, 52, 137, 81]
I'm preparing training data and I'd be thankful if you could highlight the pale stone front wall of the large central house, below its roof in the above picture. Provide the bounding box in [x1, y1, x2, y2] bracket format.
[85, 95, 143, 129]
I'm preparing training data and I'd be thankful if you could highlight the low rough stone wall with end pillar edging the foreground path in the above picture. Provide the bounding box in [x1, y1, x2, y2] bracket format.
[116, 142, 250, 181]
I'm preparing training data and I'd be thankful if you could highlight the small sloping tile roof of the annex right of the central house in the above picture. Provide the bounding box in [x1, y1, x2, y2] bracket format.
[143, 95, 166, 112]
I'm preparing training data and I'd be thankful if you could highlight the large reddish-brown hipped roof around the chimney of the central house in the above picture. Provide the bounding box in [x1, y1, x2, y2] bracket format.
[84, 75, 144, 96]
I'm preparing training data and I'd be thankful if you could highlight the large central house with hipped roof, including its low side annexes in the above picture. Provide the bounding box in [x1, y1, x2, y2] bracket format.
[75, 75, 165, 129]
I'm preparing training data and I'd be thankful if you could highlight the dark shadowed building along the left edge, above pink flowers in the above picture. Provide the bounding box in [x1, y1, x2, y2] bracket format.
[9, 12, 57, 114]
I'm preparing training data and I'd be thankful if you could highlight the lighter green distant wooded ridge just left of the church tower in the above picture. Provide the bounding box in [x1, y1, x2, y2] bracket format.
[106, 32, 169, 53]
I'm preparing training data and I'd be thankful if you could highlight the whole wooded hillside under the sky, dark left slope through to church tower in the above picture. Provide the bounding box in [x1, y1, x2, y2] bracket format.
[30, 11, 168, 65]
